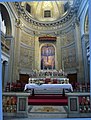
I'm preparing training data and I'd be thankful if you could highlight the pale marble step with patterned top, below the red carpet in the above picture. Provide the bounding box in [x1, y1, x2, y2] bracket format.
[28, 105, 67, 119]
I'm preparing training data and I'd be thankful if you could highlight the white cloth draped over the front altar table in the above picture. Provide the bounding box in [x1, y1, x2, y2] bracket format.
[24, 83, 73, 91]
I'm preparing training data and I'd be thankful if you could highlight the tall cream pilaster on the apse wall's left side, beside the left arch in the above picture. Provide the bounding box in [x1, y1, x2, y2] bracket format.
[12, 19, 22, 81]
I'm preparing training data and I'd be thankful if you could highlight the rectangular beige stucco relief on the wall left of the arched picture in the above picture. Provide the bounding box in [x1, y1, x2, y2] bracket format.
[20, 47, 32, 69]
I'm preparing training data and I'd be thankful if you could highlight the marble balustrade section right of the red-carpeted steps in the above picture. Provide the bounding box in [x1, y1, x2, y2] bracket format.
[67, 93, 91, 117]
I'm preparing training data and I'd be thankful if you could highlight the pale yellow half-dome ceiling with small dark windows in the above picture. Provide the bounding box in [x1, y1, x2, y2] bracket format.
[20, 0, 73, 22]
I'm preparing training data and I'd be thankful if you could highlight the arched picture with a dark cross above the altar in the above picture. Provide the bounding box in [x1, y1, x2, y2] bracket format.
[41, 44, 55, 70]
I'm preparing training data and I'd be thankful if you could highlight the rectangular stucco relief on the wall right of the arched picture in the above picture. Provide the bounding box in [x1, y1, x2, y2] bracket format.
[62, 45, 76, 69]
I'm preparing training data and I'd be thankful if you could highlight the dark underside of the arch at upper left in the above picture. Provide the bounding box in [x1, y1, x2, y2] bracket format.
[0, 3, 12, 36]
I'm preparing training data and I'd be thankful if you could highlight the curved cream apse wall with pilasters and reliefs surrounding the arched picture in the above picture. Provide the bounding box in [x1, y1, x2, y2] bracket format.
[0, 2, 87, 82]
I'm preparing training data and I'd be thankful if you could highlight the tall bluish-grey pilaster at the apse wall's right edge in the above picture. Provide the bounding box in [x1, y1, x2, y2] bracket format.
[74, 20, 84, 83]
